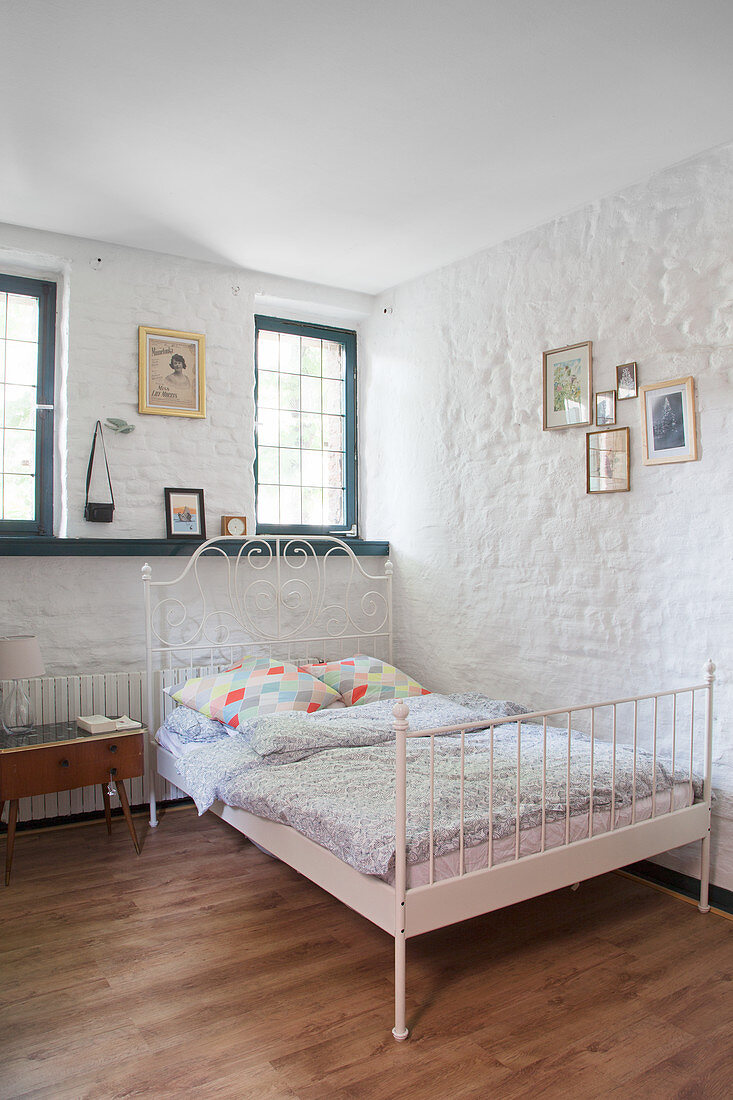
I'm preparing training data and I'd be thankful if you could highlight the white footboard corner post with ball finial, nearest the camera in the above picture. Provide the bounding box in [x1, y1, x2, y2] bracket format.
[392, 703, 409, 1043]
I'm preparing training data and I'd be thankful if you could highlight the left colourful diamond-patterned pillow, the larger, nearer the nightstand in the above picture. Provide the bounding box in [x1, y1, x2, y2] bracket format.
[169, 657, 339, 729]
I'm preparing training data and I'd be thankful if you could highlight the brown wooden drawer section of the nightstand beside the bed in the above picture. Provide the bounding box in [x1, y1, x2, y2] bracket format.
[0, 733, 143, 801]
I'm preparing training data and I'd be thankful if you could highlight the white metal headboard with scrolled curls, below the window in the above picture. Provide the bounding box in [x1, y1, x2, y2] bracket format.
[142, 535, 392, 704]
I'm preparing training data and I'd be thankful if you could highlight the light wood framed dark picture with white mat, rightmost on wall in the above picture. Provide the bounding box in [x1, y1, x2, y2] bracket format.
[639, 376, 698, 466]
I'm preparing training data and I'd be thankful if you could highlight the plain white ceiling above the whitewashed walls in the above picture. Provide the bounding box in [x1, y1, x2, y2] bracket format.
[0, 0, 733, 293]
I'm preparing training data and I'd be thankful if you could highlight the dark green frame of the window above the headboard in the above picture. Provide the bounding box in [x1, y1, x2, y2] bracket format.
[254, 316, 358, 536]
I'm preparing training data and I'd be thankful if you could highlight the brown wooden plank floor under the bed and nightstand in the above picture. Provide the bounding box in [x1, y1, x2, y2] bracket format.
[0, 811, 733, 1100]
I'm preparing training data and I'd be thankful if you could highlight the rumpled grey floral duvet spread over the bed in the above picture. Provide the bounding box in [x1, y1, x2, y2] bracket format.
[162, 693, 702, 877]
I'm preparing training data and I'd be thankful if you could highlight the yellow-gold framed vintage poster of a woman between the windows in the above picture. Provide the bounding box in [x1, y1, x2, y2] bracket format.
[138, 325, 206, 417]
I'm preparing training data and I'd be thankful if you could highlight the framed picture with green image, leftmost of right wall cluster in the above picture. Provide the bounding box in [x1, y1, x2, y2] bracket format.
[543, 340, 593, 431]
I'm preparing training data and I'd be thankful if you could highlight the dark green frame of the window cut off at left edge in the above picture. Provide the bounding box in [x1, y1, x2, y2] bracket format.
[0, 274, 56, 535]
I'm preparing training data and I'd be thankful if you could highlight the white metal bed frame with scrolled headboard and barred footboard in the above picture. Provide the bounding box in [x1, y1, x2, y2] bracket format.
[142, 535, 714, 1041]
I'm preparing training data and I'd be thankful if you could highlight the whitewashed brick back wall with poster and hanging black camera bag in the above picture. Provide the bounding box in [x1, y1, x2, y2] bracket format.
[0, 226, 371, 674]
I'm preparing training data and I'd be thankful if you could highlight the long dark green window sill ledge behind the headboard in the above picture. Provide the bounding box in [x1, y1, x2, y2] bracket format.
[0, 535, 390, 558]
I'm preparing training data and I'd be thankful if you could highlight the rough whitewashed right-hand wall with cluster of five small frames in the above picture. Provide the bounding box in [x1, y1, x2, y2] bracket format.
[361, 146, 733, 889]
